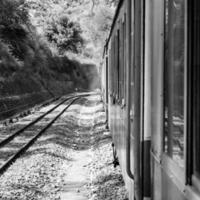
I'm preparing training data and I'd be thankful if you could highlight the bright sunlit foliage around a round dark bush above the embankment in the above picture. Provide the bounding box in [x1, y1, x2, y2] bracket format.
[26, 0, 118, 63]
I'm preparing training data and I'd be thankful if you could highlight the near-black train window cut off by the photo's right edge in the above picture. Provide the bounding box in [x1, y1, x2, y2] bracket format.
[189, 0, 200, 179]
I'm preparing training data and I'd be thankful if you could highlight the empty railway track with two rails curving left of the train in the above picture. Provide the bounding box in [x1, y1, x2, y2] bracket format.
[0, 93, 90, 174]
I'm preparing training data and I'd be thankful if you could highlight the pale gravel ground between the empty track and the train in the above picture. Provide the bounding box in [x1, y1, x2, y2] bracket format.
[0, 95, 128, 200]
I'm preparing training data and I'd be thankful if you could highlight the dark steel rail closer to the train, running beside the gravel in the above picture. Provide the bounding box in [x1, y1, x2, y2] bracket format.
[0, 94, 86, 174]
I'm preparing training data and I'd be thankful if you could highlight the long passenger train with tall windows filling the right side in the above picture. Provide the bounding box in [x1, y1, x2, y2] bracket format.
[102, 0, 200, 200]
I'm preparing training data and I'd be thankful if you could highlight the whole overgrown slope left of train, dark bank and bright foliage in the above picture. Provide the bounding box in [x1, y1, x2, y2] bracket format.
[0, 0, 116, 99]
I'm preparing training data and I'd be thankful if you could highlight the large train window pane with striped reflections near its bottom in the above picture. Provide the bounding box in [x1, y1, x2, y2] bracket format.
[164, 0, 185, 167]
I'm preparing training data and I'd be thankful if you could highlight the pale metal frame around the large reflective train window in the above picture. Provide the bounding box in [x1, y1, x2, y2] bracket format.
[161, 0, 187, 191]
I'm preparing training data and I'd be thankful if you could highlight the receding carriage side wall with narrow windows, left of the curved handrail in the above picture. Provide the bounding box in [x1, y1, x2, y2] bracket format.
[107, 2, 133, 198]
